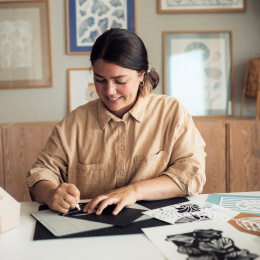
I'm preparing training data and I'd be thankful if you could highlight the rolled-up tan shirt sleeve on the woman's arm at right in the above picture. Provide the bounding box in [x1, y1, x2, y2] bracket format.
[162, 116, 206, 195]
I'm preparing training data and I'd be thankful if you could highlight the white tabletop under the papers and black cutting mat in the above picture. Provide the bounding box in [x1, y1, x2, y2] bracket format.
[0, 191, 260, 260]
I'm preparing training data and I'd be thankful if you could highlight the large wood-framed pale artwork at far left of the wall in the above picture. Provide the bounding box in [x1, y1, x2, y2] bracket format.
[0, 0, 52, 89]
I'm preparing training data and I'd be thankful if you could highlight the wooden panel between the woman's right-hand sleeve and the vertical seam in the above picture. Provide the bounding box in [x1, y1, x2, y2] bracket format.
[194, 120, 227, 193]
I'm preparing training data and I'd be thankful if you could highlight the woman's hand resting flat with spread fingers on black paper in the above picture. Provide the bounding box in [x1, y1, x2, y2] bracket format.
[83, 185, 137, 215]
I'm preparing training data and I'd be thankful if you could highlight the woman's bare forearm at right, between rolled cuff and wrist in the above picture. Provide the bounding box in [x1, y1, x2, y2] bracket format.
[131, 175, 187, 200]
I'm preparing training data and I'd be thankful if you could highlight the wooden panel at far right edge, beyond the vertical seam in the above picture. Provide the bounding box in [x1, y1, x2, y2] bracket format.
[228, 120, 260, 192]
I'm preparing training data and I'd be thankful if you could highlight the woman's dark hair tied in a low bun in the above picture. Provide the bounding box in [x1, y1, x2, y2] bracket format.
[90, 28, 159, 95]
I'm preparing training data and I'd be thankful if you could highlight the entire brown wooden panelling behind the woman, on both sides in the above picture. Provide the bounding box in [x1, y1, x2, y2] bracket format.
[0, 119, 260, 201]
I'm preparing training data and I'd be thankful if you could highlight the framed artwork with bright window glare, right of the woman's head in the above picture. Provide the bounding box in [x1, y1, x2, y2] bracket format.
[163, 31, 233, 116]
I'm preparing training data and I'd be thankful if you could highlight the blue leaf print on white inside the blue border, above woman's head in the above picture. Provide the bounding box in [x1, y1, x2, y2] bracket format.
[76, 0, 127, 46]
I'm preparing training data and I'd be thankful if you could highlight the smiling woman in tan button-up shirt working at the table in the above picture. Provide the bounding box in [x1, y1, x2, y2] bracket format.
[27, 29, 205, 215]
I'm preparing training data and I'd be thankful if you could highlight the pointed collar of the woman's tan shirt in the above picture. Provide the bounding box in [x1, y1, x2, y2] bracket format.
[98, 96, 148, 129]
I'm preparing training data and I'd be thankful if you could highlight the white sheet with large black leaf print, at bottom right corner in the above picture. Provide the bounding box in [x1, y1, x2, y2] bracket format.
[142, 220, 260, 260]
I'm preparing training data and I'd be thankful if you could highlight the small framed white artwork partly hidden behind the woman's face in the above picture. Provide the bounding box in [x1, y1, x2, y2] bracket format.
[68, 68, 98, 112]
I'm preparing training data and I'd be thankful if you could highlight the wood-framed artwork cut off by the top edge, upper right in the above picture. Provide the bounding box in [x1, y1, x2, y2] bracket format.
[157, 0, 246, 14]
